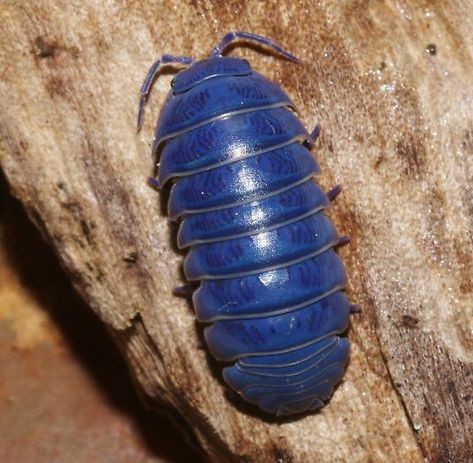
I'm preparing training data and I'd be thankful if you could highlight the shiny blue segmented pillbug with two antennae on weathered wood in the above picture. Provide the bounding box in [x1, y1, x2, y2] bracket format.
[138, 32, 354, 416]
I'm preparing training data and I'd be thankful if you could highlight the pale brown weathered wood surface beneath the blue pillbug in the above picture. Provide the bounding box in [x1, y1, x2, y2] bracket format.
[0, 0, 473, 462]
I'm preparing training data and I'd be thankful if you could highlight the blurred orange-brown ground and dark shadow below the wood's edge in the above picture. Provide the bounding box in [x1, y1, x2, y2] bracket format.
[0, 179, 204, 463]
